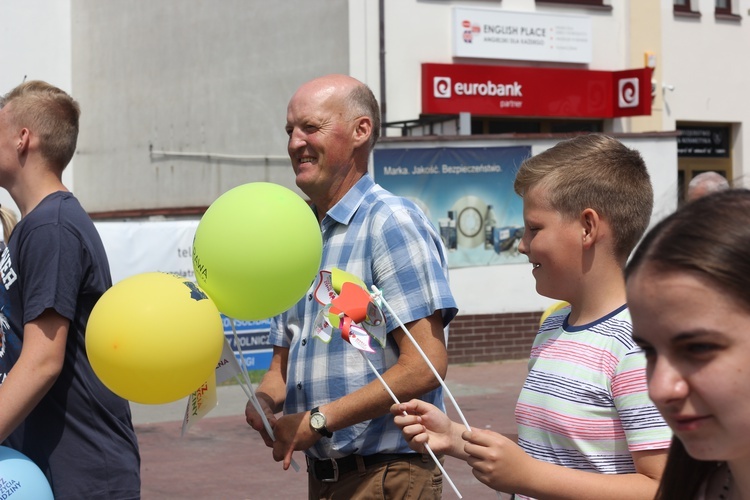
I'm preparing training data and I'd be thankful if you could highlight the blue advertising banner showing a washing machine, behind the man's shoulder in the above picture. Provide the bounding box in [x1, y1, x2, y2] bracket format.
[374, 146, 531, 268]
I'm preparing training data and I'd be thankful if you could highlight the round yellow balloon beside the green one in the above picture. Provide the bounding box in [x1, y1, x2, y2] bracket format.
[86, 272, 224, 404]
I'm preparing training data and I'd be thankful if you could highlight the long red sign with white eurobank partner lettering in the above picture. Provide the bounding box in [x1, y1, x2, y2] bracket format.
[422, 63, 652, 119]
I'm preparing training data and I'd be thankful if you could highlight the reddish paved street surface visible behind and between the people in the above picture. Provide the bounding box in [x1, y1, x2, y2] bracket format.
[131, 360, 526, 500]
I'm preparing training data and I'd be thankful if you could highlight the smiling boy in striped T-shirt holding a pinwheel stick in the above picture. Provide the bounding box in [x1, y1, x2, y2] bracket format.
[392, 134, 671, 500]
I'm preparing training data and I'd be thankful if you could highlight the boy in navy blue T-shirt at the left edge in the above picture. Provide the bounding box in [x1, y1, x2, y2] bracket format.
[0, 81, 140, 500]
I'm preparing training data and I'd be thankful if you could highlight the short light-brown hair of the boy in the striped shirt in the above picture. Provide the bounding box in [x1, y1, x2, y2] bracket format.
[513, 134, 654, 259]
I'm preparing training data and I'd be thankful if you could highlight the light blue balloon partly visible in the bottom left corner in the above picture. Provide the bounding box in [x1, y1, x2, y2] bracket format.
[0, 446, 55, 500]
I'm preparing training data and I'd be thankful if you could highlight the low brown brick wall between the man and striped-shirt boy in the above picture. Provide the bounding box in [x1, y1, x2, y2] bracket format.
[448, 312, 542, 364]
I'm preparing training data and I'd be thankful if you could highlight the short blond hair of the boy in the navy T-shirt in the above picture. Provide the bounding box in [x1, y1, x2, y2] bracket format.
[0, 80, 81, 171]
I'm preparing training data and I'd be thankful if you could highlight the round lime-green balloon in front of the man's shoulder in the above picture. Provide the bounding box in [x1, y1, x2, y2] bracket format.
[193, 182, 323, 321]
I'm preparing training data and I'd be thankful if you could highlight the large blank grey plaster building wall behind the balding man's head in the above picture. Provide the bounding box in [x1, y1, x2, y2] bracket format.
[72, 0, 350, 212]
